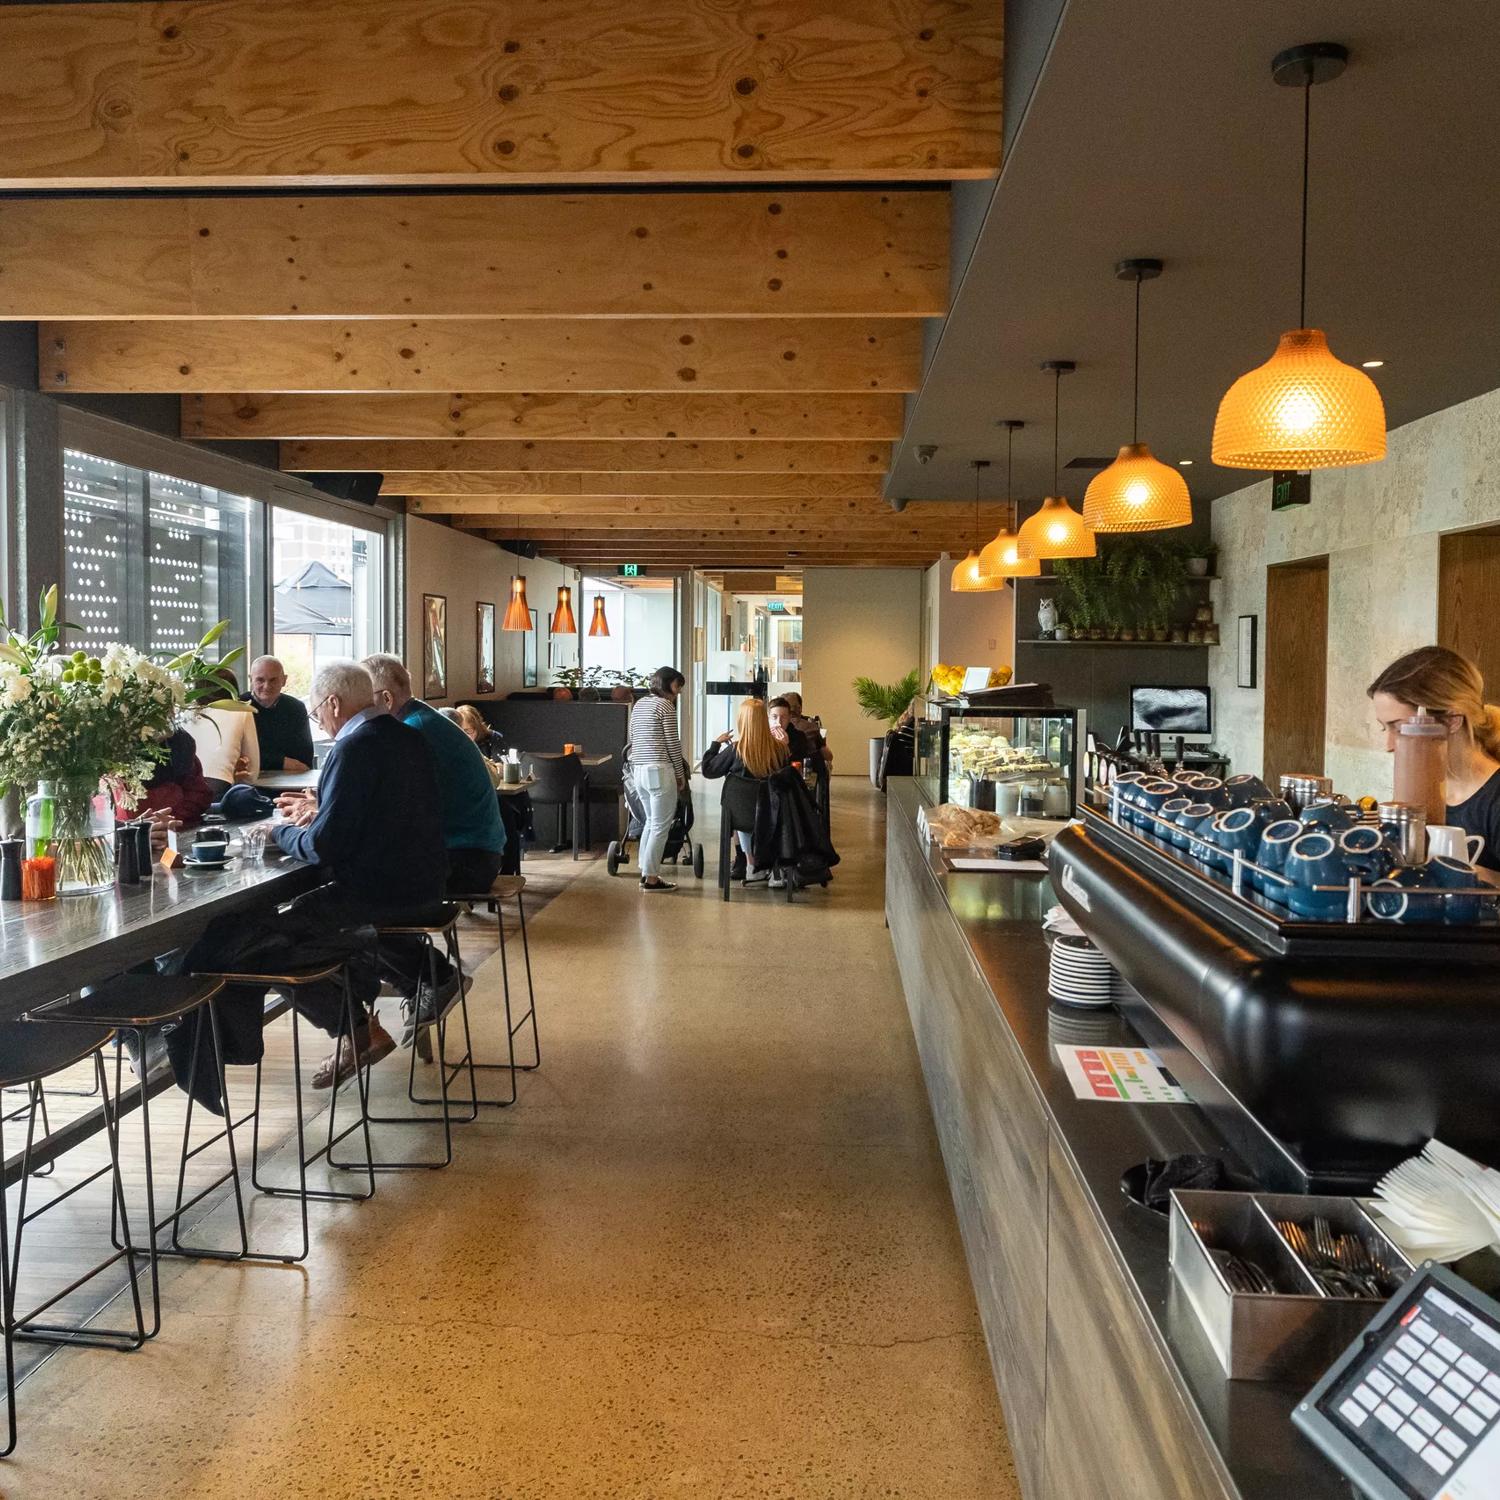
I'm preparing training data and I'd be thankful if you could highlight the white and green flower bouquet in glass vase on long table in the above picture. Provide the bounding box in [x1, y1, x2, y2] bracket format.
[0, 585, 249, 891]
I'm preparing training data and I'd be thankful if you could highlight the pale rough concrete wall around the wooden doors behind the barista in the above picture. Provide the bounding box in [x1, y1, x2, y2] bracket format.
[1209, 392, 1500, 797]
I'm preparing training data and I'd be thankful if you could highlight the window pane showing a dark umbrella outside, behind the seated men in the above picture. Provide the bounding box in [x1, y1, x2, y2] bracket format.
[272, 507, 386, 699]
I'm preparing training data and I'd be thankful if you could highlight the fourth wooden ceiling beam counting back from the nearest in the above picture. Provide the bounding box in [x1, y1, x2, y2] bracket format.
[182, 392, 905, 443]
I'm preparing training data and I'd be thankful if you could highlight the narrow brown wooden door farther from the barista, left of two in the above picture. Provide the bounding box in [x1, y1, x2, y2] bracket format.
[1262, 558, 1328, 788]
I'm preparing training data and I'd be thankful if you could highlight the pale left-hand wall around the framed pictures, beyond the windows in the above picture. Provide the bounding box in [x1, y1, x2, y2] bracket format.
[407, 516, 573, 704]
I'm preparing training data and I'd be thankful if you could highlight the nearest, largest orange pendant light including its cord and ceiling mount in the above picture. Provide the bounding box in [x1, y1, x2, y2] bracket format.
[1214, 42, 1386, 470]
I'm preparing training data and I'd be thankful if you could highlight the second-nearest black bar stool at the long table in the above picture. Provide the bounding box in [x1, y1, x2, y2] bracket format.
[27, 974, 244, 1338]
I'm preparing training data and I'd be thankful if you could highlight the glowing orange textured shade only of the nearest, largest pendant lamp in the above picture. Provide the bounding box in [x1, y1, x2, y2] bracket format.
[1214, 329, 1386, 470]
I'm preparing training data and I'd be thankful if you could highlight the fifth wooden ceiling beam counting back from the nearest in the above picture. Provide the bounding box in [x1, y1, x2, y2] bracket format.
[281, 441, 891, 474]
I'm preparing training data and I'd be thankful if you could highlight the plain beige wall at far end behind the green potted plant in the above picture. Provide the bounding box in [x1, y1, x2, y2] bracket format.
[803, 567, 923, 776]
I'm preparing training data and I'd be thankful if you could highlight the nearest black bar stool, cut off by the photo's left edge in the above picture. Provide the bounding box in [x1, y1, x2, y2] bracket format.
[0, 1022, 147, 1458]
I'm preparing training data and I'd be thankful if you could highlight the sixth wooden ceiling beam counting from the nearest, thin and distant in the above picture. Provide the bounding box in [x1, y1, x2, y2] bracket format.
[399, 474, 885, 498]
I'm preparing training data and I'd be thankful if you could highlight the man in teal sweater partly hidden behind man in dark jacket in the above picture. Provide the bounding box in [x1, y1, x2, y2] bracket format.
[363, 654, 506, 1044]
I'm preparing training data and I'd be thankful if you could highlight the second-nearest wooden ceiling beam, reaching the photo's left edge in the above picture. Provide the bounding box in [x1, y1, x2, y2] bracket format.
[0, 192, 948, 319]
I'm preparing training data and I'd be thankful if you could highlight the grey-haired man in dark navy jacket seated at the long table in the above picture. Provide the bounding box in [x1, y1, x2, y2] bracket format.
[173, 662, 449, 1092]
